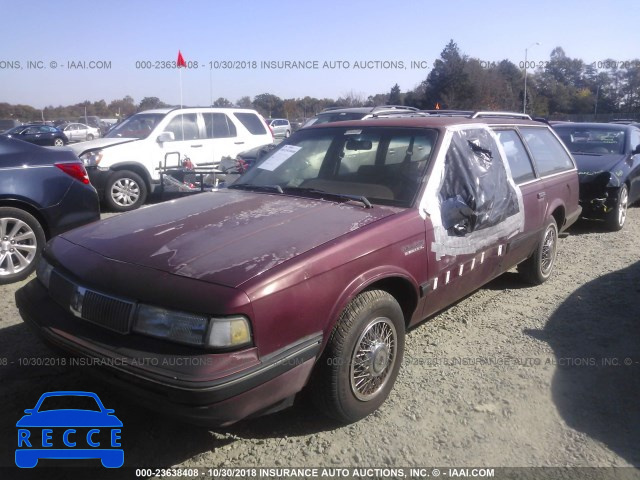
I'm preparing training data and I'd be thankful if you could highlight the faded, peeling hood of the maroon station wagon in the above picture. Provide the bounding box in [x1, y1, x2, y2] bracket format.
[63, 190, 401, 287]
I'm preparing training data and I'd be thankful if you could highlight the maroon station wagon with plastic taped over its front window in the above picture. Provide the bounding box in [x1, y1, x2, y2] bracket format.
[16, 114, 580, 425]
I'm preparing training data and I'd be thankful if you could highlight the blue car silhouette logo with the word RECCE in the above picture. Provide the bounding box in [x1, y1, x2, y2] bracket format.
[16, 391, 124, 468]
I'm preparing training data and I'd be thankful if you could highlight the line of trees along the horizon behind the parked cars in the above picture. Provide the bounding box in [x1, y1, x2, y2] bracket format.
[0, 40, 640, 121]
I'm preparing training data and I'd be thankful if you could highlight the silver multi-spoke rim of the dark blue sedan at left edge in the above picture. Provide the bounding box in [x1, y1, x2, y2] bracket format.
[0, 217, 37, 275]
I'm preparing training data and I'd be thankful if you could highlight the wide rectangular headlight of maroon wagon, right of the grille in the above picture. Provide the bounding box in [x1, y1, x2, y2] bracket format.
[133, 305, 251, 348]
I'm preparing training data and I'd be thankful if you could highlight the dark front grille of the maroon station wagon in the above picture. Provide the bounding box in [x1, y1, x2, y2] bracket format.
[49, 270, 135, 333]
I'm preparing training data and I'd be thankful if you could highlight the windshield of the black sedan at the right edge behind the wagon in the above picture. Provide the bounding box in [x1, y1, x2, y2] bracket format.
[554, 125, 625, 155]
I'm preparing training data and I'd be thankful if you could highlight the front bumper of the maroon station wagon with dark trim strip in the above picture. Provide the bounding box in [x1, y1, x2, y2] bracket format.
[16, 279, 322, 425]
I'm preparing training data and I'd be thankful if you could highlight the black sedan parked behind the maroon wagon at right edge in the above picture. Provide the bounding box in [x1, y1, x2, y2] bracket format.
[553, 123, 640, 230]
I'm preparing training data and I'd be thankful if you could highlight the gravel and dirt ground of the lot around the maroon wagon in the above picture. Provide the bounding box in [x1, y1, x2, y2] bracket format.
[0, 207, 640, 478]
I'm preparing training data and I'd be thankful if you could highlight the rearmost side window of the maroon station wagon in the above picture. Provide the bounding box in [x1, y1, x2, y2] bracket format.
[519, 127, 574, 176]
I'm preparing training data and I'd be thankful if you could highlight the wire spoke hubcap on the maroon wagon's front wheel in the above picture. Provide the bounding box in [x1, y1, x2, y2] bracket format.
[350, 317, 397, 402]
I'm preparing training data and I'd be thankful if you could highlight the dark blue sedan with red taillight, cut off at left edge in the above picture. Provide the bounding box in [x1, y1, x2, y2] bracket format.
[0, 137, 100, 284]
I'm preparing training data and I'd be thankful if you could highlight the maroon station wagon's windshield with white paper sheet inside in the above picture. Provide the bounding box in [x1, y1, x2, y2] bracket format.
[230, 127, 437, 207]
